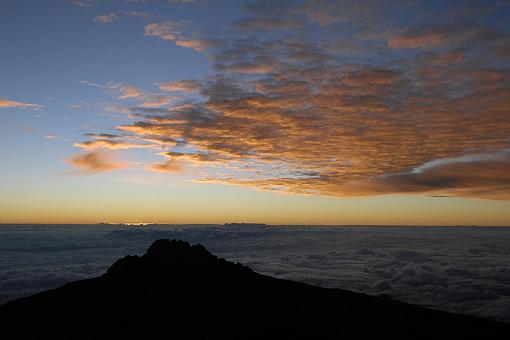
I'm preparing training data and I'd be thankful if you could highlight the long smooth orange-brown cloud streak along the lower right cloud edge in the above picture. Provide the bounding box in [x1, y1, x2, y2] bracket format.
[209, 150, 510, 200]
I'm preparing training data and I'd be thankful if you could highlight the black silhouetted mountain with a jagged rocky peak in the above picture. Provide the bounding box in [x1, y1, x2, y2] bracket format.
[0, 240, 510, 339]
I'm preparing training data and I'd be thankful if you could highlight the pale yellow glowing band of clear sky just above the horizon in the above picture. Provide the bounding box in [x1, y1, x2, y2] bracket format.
[0, 179, 510, 226]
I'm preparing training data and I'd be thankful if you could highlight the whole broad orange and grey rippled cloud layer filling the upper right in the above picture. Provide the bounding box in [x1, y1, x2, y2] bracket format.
[71, 0, 510, 199]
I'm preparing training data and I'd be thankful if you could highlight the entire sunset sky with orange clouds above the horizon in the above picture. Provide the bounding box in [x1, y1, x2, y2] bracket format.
[0, 0, 510, 225]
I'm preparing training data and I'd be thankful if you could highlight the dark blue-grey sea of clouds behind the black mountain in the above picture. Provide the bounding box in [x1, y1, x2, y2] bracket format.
[0, 225, 510, 321]
